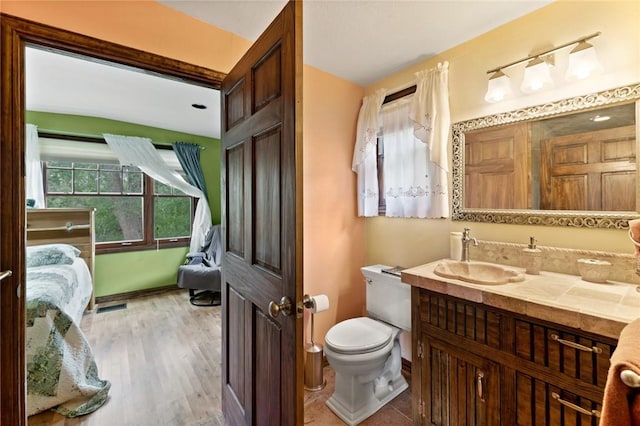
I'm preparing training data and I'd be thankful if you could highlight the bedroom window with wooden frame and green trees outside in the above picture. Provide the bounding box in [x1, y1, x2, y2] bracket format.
[43, 138, 195, 253]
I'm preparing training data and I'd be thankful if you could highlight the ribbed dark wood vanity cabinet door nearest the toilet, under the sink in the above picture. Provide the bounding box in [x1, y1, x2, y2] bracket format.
[422, 334, 500, 426]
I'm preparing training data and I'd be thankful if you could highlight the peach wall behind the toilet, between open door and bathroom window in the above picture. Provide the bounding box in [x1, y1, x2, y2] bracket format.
[303, 66, 365, 343]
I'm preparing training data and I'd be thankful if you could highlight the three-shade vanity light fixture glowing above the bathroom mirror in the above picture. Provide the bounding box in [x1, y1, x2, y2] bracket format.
[484, 32, 602, 103]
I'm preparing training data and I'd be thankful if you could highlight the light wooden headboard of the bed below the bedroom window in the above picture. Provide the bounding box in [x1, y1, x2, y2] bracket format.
[27, 209, 95, 310]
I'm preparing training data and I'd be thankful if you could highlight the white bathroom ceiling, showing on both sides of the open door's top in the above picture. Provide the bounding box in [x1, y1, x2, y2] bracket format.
[162, 0, 551, 87]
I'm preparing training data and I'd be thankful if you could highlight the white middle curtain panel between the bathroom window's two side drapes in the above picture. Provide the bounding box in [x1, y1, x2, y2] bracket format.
[381, 99, 446, 218]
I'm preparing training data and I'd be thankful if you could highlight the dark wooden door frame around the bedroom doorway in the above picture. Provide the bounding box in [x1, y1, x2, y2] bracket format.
[0, 13, 226, 426]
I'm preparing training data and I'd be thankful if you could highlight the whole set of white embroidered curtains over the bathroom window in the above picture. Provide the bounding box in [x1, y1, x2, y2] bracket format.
[352, 62, 451, 218]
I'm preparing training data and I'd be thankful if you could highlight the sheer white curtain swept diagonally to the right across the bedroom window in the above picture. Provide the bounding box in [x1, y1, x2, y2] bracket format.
[104, 134, 211, 252]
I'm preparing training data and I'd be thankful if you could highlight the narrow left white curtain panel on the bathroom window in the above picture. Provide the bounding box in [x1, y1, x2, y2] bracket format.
[351, 89, 386, 216]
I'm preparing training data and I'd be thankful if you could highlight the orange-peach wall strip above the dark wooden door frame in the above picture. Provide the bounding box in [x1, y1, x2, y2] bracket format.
[0, 0, 251, 73]
